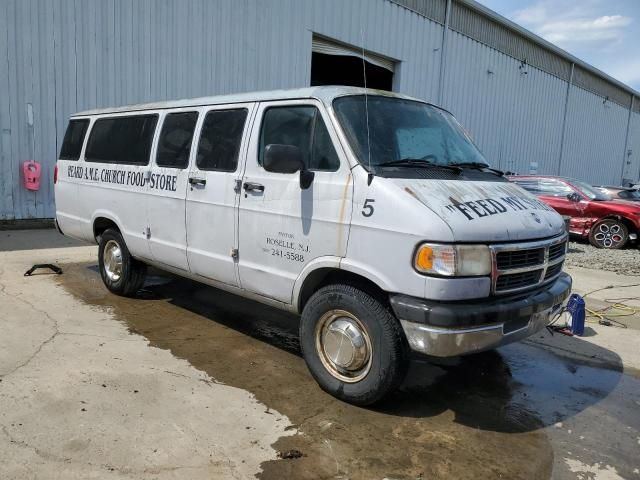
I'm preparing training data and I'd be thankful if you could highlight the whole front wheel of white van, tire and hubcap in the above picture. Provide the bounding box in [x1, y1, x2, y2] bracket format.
[300, 284, 408, 405]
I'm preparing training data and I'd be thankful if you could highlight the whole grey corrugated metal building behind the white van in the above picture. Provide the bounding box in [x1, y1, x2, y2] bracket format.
[0, 0, 640, 220]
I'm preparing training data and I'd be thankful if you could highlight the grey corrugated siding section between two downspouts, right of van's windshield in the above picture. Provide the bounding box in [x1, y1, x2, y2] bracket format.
[443, 32, 566, 174]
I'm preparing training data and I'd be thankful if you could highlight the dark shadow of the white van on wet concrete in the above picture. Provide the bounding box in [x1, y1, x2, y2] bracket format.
[127, 268, 623, 433]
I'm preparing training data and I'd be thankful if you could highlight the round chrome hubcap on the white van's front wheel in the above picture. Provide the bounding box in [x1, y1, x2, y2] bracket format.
[316, 310, 371, 383]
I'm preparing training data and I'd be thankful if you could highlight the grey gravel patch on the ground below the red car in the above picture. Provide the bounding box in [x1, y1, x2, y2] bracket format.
[565, 241, 640, 275]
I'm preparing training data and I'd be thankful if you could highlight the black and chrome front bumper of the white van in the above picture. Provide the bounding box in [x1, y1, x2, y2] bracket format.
[390, 273, 572, 357]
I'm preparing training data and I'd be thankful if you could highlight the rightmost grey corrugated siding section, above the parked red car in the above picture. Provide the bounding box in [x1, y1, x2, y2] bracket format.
[560, 86, 629, 185]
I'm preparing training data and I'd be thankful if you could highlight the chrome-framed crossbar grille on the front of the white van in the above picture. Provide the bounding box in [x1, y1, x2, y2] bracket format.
[491, 234, 567, 294]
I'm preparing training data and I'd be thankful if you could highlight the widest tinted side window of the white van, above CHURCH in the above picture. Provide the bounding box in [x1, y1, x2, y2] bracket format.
[85, 114, 158, 165]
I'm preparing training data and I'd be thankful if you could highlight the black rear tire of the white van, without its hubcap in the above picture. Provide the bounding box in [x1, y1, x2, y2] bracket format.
[98, 229, 147, 297]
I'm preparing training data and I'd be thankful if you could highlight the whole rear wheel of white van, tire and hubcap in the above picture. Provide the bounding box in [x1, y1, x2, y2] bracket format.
[98, 229, 147, 297]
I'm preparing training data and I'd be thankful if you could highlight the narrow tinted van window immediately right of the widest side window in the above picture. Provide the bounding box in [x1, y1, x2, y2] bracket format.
[156, 112, 198, 168]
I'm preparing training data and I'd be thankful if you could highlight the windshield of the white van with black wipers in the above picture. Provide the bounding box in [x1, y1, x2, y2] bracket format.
[333, 95, 489, 170]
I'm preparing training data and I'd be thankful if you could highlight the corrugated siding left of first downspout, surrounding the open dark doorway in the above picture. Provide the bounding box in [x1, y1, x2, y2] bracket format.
[0, 0, 450, 219]
